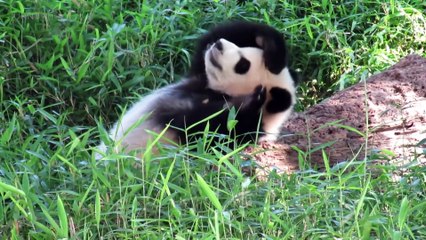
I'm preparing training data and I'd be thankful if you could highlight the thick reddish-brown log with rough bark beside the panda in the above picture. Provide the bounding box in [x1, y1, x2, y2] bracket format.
[247, 55, 426, 174]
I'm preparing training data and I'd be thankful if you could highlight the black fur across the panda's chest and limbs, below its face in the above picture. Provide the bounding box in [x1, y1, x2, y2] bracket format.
[152, 82, 266, 142]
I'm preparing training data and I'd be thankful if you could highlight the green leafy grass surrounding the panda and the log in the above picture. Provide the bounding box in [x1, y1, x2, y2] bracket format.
[0, 0, 426, 239]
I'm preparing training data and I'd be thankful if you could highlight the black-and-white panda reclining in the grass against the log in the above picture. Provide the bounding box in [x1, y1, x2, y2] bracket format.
[99, 22, 295, 156]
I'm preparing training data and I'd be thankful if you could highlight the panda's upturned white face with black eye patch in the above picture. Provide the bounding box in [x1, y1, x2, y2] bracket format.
[204, 38, 270, 95]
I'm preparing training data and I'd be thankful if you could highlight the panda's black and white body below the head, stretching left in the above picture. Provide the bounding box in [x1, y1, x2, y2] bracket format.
[99, 79, 266, 154]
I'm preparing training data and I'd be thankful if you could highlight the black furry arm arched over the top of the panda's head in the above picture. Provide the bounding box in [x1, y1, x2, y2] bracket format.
[189, 21, 288, 76]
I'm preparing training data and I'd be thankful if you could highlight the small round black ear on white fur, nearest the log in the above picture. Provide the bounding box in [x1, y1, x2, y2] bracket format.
[266, 87, 293, 113]
